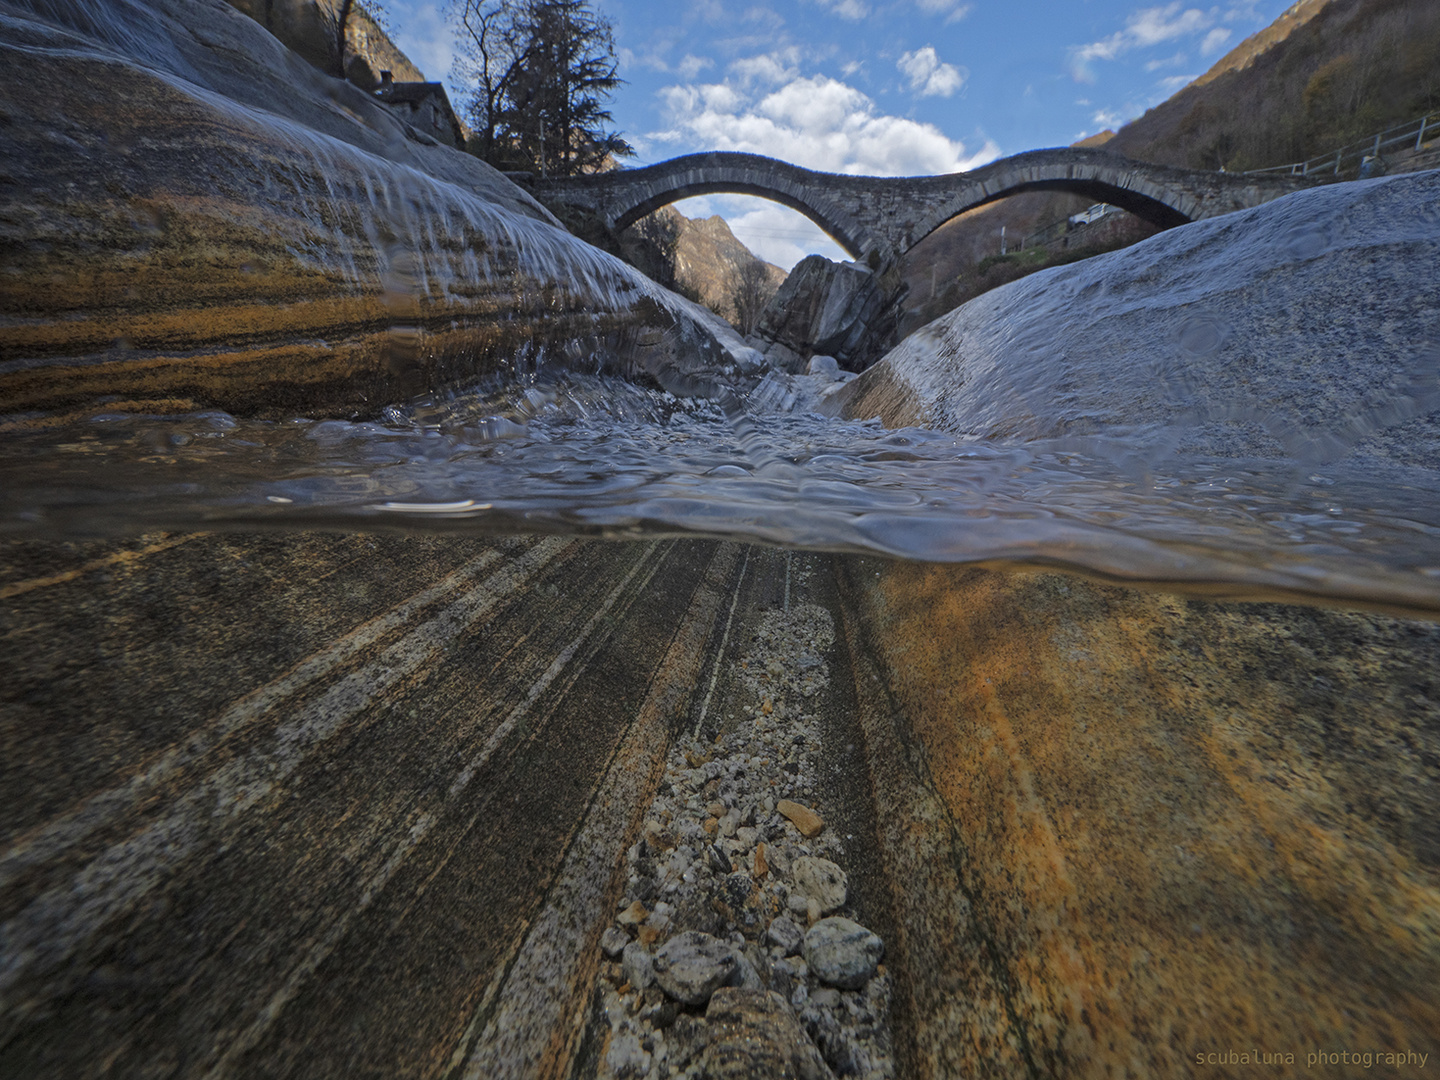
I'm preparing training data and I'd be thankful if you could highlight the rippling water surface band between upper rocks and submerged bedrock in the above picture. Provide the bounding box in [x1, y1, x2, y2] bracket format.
[0, 376, 1440, 613]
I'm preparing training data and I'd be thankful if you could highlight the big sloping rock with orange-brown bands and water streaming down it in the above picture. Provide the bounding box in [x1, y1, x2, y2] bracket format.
[0, 0, 733, 416]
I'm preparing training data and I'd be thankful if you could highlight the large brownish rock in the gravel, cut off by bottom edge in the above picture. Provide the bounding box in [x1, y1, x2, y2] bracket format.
[703, 986, 834, 1080]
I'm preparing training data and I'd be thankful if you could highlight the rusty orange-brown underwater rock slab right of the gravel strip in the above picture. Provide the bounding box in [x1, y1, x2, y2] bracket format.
[835, 560, 1440, 1077]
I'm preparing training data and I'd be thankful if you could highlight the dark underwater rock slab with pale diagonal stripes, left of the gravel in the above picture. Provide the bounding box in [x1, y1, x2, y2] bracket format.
[0, 534, 739, 1079]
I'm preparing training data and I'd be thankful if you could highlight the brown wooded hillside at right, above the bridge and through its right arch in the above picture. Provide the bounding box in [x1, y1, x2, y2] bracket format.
[901, 0, 1440, 331]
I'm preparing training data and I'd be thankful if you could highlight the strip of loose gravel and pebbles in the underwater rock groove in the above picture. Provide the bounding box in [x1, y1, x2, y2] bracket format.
[598, 605, 894, 1080]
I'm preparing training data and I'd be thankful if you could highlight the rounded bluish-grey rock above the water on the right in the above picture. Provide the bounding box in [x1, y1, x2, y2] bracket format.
[847, 171, 1440, 469]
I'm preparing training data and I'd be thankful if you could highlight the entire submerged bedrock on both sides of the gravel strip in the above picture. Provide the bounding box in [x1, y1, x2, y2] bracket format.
[0, 533, 1440, 1080]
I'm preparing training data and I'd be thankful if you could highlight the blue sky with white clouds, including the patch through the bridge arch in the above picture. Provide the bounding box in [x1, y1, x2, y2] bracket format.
[384, 0, 1290, 268]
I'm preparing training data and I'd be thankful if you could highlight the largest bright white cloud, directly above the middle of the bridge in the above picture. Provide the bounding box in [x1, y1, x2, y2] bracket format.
[649, 75, 999, 176]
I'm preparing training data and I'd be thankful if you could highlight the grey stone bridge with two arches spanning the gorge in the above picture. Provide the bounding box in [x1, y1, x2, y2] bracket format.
[531, 150, 1310, 266]
